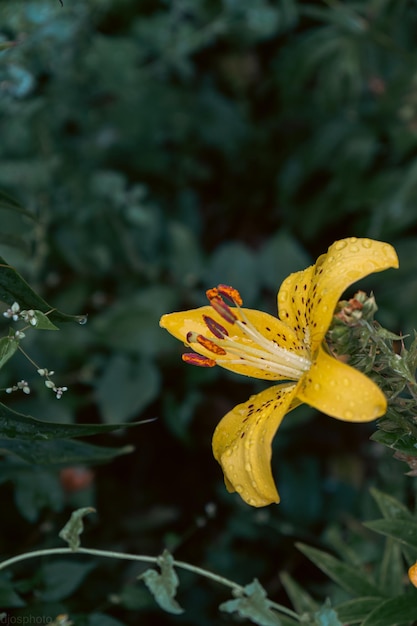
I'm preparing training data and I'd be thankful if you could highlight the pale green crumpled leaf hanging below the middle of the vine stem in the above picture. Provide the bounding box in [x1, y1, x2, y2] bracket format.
[139, 550, 184, 615]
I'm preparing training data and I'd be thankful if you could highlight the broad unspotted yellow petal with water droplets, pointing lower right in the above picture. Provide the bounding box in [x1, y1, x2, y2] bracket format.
[297, 348, 387, 422]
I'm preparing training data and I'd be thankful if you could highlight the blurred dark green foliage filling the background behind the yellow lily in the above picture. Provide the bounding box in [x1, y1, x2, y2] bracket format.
[0, 0, 417, 626]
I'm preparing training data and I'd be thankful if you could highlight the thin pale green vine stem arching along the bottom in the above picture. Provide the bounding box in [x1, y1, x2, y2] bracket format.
[0, 547, 300, 621]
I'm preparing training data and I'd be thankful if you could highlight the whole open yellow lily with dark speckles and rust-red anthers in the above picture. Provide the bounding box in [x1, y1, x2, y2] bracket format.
[160, 237, 398, 507]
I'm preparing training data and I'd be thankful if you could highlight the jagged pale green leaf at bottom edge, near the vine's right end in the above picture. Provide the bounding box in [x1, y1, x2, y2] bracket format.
[219, 578, 281, 626]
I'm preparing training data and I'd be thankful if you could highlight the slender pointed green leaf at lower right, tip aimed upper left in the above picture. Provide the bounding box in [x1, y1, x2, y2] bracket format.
[296, 543, 381, 596]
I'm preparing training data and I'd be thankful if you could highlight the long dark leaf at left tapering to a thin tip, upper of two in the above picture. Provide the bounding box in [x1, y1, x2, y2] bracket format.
[0, 402, 152, 441]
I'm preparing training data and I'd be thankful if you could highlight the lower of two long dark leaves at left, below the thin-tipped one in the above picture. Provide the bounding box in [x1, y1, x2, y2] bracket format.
[0, 437, 133, 467]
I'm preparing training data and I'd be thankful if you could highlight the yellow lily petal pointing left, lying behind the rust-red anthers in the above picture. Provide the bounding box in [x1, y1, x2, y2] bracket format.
[159, 306, 308, 380]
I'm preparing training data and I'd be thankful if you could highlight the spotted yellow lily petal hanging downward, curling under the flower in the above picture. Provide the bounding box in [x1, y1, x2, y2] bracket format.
[213, 383, 300, 507]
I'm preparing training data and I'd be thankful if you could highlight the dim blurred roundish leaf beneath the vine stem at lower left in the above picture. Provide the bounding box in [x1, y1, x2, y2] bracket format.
[37, 560, 95, 602]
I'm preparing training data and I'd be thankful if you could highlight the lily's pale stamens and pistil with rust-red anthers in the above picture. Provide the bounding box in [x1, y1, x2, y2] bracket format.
[184, 285, 311, 380]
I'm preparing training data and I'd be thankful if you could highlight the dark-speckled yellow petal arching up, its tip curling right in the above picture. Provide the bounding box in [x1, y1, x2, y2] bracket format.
[278, 237, 398, 353]
